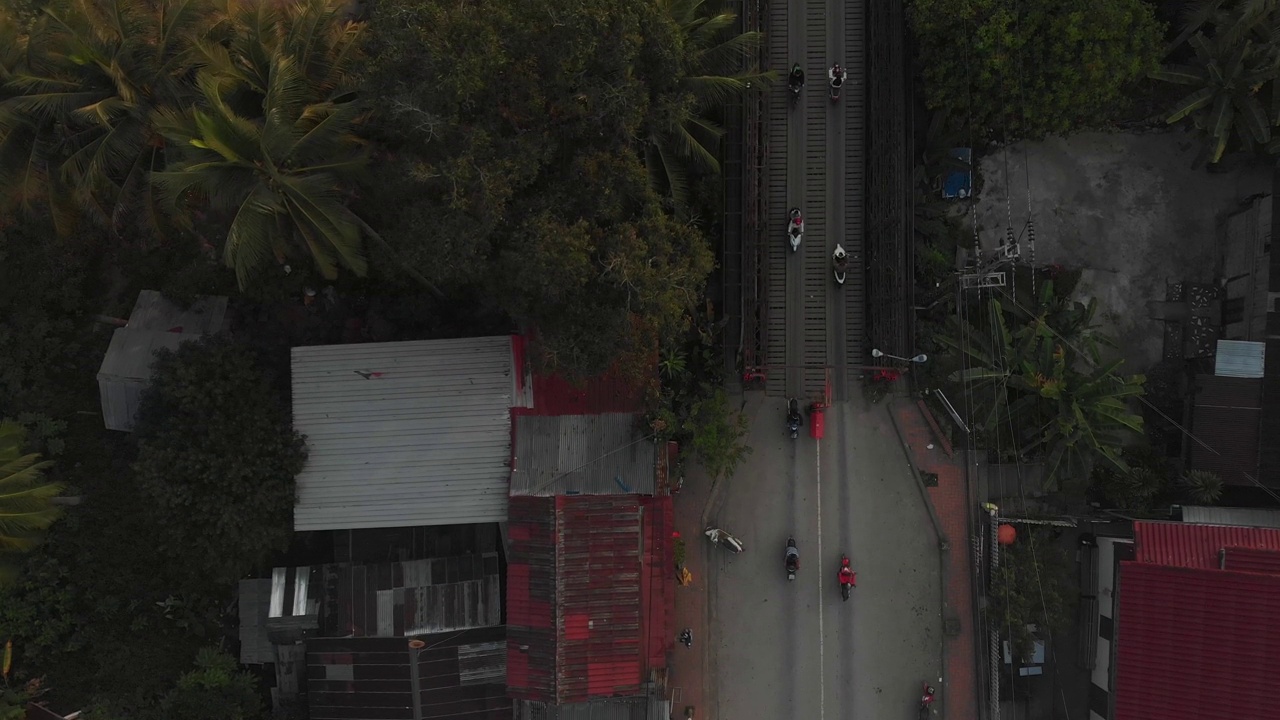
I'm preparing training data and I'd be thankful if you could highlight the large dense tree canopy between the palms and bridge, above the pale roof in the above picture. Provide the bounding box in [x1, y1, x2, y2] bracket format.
[365, 0, 712, 373]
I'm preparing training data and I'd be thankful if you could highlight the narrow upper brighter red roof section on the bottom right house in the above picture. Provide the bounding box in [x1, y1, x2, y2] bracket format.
[1133, 521, 1280, 569]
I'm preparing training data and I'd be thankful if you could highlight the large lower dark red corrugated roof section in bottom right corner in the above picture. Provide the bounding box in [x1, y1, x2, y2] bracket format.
[1114, 562, 1280, 720]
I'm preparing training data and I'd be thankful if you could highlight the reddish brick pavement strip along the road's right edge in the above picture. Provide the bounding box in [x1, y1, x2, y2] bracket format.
[890, 401, 979, 720]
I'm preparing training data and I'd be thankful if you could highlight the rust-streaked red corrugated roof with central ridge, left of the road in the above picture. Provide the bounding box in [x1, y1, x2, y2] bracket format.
[507, 496, 644, 703]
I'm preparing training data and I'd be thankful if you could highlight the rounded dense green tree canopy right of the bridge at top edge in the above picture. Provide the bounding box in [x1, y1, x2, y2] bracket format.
[910, 0, 1164, 140]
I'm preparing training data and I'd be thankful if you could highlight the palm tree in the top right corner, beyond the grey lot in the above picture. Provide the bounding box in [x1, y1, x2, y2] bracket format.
[1151, 32, 1280, 163]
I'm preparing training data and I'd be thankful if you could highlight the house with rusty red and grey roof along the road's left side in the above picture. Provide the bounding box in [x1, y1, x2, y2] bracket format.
[507, 366, 675, 720]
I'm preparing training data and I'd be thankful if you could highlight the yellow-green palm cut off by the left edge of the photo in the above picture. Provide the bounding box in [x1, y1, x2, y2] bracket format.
[0, 420, 63, 583]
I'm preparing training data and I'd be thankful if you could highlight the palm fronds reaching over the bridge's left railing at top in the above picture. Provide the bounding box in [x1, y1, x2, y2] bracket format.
[645, 0, 776, 213]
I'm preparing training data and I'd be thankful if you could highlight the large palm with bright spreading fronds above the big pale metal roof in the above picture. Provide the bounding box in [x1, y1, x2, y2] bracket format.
[152, 54, 369, 288]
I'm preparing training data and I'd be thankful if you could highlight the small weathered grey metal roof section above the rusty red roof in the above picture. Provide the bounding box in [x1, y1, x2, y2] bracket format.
[511, 413, 658, 496]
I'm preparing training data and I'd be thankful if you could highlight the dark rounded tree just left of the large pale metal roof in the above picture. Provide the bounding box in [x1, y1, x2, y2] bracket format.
[133, 337, 306, 583]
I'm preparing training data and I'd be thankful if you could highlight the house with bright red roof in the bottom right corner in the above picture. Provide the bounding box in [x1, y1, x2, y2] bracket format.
[1089, 521, 1280, 720]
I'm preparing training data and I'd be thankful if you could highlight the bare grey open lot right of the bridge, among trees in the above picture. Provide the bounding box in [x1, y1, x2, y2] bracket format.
[978, 131, 1272, 373]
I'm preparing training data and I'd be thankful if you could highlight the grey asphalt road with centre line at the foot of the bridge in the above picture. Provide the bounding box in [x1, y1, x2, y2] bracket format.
[705, 393, 942, 720]
